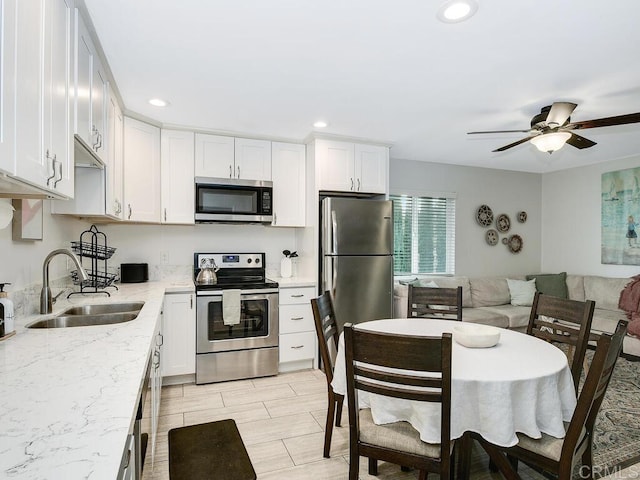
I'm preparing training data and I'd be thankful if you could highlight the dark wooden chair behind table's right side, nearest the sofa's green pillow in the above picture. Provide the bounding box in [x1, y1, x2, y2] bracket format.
[527, 292, 596, 394]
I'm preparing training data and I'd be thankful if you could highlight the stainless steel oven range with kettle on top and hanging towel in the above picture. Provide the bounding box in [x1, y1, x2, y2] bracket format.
[194, 253, 278, 384]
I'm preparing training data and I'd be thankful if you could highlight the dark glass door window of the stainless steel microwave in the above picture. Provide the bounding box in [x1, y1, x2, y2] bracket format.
[196, 187, 259, 214]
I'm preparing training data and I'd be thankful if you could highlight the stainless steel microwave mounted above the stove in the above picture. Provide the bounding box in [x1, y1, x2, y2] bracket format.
[195, 177, 273, 223]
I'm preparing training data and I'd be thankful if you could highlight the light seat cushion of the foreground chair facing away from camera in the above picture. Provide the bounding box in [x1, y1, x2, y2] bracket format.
[359, 408, 440, 459]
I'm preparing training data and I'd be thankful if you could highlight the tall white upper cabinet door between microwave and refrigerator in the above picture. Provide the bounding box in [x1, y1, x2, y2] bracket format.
[271, 142, 306, 227]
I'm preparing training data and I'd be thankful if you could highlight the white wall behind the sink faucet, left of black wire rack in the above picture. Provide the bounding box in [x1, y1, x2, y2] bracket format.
[0, 199, 87, 292]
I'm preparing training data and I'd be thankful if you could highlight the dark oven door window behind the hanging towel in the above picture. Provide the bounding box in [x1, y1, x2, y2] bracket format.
[207, 299, 269, 341]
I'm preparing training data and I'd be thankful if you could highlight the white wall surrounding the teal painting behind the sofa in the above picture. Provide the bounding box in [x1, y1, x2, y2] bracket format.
[542, 156, 640, 277]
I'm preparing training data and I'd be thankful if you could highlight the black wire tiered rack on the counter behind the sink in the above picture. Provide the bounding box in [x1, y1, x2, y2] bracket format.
[67, 225, 118, 298]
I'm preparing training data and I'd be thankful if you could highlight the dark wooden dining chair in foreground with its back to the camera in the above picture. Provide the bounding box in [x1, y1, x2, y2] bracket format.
[344, 323, 453, 480]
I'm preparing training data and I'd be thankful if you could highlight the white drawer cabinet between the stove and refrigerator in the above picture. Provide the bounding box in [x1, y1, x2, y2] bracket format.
[279, 287, 318, 372]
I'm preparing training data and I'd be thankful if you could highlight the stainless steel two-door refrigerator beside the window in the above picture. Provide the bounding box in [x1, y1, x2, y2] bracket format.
[320, 197, 393, 331]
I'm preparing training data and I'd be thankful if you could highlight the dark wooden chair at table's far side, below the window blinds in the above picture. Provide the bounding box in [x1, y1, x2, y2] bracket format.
[407, 285, 462, 321]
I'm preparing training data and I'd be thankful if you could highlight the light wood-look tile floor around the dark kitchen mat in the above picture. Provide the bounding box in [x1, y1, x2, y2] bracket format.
[143, 370, 640, 480]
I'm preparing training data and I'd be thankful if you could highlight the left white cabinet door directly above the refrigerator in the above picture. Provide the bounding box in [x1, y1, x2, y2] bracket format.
[315, 140, 356, 192]
